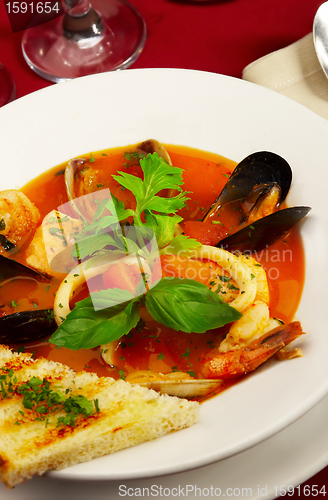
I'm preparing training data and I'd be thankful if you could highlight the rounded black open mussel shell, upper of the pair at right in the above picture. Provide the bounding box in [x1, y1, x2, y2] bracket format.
[203, 151, 292, 221]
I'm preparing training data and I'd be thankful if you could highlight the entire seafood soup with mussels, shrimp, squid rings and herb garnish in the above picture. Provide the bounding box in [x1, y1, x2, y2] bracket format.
[0, 140, 309, 399]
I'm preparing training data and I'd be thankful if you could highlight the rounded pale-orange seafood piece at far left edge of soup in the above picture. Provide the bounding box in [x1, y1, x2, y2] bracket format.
[0, 189, 40, 246]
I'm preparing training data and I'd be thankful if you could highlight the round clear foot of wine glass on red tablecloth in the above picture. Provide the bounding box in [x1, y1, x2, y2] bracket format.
[22, 0, 146, 82]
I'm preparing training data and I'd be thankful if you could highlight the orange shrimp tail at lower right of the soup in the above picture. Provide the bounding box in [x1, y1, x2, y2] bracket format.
[202, 321, 304, 379]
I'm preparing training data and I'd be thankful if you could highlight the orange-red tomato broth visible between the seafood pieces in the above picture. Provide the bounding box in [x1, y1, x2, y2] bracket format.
[0, 146, 304, 378]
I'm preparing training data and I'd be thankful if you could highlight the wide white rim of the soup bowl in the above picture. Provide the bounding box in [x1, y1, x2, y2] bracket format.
[0, 69, 328, 479]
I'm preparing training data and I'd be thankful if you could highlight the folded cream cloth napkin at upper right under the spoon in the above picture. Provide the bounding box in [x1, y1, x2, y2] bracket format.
[243, 33, 328, 119]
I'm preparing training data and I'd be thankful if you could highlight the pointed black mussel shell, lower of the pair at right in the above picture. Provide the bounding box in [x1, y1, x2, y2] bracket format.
[216, 207, 311, 252]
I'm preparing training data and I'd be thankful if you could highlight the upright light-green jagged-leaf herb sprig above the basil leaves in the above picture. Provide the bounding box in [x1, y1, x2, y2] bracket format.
[73, 153, 200, 266]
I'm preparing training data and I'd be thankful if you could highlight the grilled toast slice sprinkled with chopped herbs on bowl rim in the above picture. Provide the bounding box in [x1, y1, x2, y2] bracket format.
[0, 346, 199, 488]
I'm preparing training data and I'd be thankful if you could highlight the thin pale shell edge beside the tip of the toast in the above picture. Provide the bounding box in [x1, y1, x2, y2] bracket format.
[130, 379, 222, 399]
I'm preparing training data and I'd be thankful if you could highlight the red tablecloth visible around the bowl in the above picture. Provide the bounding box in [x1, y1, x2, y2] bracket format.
[0, 0, 328, 498]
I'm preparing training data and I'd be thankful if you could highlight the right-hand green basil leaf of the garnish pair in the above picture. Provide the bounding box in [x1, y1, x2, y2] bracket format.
[145, 278, 242, 333]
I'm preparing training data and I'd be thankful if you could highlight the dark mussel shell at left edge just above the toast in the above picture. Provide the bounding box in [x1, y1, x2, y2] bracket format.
[0, 309, 57, 345]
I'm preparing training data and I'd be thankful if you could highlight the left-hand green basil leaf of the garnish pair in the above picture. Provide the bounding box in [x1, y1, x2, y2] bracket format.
[49, 290, 140, 350]
